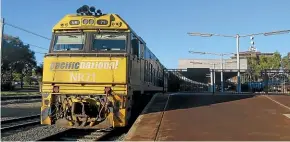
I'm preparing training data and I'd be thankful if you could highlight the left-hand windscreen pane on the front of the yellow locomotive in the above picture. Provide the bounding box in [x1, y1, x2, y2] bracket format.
[53, 35, 85, 51]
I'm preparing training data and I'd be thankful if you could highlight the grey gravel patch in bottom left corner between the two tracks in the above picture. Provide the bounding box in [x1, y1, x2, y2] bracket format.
[1, 125, 67, 141]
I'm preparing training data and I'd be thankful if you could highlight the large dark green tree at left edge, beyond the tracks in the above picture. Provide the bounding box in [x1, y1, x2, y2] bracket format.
[1, 35, 36, 88]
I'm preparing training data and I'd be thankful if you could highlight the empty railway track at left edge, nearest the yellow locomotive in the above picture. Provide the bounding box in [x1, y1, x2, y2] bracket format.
[1, 114, 40, 133]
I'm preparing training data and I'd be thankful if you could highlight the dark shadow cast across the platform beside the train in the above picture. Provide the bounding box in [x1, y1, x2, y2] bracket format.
[143, 93, 256, 114]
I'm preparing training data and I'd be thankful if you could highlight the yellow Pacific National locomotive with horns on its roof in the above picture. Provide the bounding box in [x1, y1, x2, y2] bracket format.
[41, 5, 167, 128]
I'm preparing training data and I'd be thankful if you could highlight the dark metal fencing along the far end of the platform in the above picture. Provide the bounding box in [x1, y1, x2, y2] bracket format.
[164, 69, 290, 94]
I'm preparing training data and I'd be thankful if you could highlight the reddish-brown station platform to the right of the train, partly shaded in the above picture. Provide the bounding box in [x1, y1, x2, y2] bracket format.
[124, 93, 290, 141]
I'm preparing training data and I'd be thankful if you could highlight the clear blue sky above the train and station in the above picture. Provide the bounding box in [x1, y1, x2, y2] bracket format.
[2, 0, 290, 68]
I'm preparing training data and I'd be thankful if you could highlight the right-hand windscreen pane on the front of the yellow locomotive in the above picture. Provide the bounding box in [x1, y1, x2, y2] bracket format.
[93, 33, 126, 51]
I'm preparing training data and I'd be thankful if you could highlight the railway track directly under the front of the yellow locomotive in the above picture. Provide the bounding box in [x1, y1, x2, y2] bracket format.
[37, 129, 117, 141]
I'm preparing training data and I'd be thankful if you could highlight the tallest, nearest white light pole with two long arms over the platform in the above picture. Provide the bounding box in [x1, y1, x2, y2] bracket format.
[187, 30, 290, 93]
